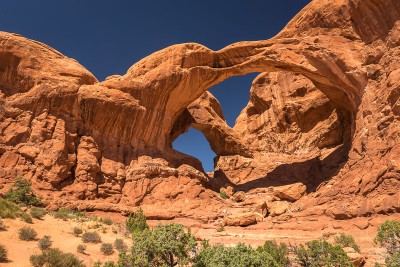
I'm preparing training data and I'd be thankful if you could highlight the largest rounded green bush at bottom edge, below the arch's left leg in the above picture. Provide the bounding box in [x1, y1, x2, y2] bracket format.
[124, 223, 197, 266]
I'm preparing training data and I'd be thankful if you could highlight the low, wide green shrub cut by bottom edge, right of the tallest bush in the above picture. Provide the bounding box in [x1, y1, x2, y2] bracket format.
[193, 241, 281, 267]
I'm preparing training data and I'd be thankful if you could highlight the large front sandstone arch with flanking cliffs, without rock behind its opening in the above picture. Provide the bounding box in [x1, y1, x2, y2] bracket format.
[0, 0, 400, 221]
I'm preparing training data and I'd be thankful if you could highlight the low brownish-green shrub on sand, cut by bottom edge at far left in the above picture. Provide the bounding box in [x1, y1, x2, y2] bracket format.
[29, 248, 85, 267]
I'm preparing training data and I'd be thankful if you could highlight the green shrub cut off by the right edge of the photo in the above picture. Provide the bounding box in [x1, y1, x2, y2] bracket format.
[374, 220, 400, 254]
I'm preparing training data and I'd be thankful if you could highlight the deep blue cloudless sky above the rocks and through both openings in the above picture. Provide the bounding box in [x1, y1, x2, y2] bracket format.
[0, 0, 310, 171]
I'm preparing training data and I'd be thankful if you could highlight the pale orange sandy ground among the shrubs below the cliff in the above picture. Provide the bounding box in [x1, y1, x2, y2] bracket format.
[0, 213, 400, 267]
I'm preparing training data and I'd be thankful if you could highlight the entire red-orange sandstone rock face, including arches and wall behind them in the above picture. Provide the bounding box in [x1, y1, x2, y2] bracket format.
[0, 0, 400, 221]
